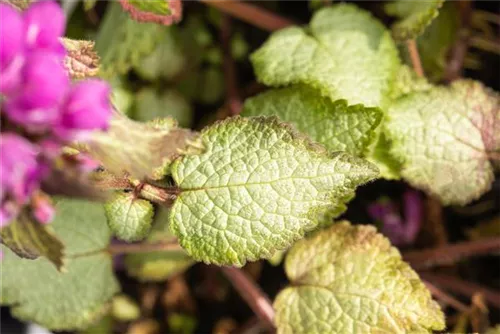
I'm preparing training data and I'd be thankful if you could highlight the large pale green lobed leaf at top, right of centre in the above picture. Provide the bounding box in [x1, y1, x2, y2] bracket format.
[251, 4, 399, 107]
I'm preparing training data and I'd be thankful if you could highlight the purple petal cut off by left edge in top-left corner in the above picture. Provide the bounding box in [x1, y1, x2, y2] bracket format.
[0, 3, 24, 93]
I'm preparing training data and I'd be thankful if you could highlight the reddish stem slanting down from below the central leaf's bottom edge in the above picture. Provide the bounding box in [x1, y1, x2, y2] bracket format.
[221, 267, 274, 328]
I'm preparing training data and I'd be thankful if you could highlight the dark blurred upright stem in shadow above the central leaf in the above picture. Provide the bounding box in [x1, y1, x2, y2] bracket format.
[220, 14, 242, 116]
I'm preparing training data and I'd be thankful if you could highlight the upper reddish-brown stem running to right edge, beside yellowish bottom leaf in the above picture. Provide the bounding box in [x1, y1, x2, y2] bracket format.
[403, 237, 500, 269]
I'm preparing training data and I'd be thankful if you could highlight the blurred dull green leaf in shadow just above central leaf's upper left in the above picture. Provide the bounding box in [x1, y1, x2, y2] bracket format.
[135, 88, 193, 127]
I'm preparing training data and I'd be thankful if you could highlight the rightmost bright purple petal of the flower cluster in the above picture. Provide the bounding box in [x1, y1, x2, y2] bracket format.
[55, 79, 113, 140]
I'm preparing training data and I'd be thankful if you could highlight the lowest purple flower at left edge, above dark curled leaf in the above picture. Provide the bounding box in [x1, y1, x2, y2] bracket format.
[0, 133, 43, 227]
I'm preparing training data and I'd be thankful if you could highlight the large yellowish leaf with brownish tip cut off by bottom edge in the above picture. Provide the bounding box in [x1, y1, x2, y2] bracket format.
[274, 222, 445, 334]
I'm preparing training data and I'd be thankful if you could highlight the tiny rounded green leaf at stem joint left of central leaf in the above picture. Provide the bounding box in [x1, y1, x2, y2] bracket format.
[104, 192, 154, 242]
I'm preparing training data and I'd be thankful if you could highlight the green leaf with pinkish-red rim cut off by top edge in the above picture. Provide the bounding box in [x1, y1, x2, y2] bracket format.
[120, 0, 182, 26]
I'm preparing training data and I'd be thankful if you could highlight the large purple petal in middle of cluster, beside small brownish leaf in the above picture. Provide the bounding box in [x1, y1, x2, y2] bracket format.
[6, 51, 70, 132]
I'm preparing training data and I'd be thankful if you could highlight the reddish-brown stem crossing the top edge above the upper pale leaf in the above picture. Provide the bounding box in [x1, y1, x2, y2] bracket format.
[201, 0, 294, 31]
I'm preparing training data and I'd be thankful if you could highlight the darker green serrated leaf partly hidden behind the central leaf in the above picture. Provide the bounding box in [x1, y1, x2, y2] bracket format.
[242, 86, 382, 156]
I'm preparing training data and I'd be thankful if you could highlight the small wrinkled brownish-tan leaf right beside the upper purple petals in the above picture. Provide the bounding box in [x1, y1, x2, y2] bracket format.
[61, 38, 99, 79]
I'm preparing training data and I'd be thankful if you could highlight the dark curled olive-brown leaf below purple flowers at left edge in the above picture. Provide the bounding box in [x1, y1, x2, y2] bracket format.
[0, 211, 64, 270]
